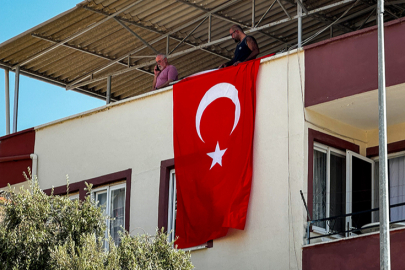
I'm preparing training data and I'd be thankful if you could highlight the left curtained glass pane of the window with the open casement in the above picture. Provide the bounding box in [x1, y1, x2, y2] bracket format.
[312, 150, 326, 229]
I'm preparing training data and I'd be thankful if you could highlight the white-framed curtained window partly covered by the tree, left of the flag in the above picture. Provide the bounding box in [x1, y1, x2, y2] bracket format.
[92, 183, 126, 248]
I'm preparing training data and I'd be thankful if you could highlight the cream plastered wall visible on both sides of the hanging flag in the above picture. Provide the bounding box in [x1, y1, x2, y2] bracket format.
[35, 53, 307, 270]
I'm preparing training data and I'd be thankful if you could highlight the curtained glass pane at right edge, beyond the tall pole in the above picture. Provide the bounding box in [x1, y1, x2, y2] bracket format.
[388, 157, 405, 221]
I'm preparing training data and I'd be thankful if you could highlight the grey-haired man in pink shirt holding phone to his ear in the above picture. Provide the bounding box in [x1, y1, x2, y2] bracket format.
[152, 54, 178, 90]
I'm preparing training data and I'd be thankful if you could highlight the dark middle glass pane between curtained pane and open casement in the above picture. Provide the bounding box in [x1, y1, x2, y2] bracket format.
[329, 153, 346, 235]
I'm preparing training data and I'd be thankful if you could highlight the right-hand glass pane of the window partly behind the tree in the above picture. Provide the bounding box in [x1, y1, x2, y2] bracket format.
[110, 188, 125, 245]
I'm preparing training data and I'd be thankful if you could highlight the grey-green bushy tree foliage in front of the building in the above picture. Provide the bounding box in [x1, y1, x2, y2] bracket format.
[0, 172, 193, 270]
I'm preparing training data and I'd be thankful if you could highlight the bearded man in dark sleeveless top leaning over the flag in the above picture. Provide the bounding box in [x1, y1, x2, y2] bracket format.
[218, 24, 260, 68]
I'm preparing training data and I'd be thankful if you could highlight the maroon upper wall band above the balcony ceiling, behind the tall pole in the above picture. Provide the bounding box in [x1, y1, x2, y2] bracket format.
[304, 18, 405, 107]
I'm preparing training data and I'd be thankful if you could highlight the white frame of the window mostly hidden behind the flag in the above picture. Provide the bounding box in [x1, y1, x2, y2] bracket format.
[167, 169, 207, 251]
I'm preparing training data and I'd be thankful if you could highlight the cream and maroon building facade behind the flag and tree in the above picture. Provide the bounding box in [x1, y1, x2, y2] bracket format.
[0, 17, 405, 269]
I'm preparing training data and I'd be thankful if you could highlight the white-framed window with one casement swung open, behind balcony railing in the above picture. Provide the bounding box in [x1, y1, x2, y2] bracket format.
[312, 142, 375, 236]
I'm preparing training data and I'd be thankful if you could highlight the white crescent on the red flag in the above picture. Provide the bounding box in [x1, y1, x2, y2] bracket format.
[195, 83, 240, 142]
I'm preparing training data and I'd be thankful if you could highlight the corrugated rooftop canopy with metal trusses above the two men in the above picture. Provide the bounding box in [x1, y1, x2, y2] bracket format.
[0, 0, 405, 100]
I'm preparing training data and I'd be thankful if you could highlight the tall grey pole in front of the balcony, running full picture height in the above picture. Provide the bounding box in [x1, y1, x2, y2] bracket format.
[377, 0, 391, 270]
